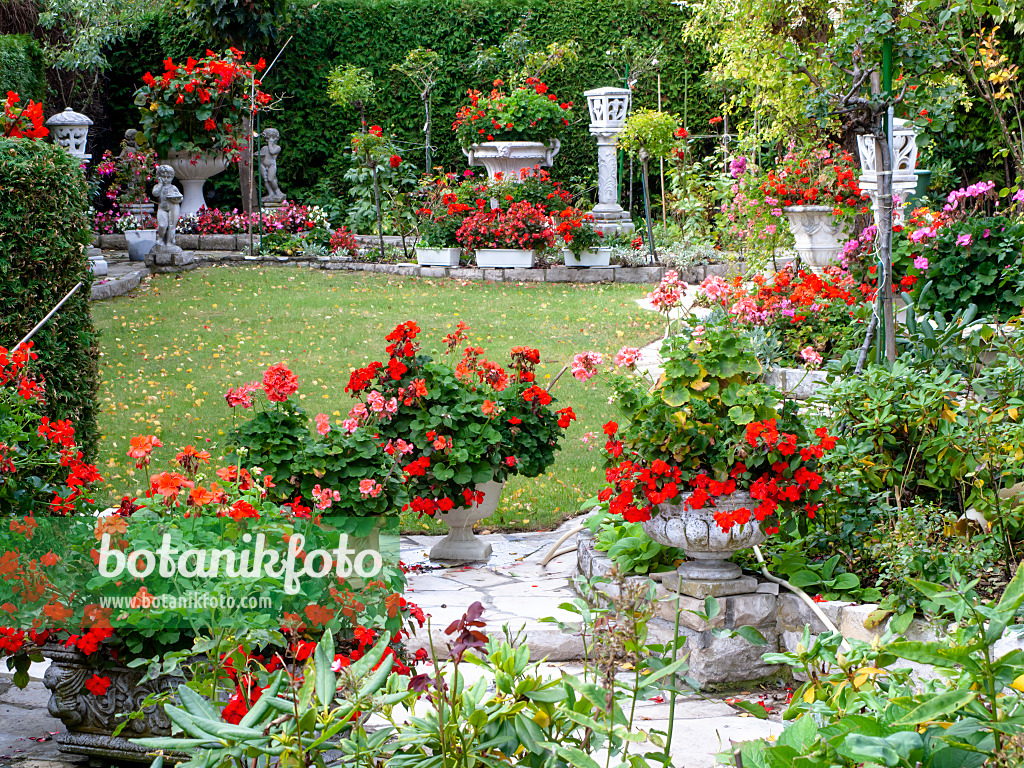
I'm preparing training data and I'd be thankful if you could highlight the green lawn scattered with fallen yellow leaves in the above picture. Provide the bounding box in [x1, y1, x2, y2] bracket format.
[93, 267, 662, 531]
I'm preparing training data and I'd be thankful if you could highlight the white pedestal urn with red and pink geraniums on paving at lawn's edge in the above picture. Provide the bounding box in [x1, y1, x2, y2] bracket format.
[343, 321, 575, 560]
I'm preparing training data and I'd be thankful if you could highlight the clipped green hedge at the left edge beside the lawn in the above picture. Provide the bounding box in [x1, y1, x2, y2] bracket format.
[0, 138, 98, 457]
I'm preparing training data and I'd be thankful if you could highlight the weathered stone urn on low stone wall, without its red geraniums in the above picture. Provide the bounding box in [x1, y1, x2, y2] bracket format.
[641, 490, 767, 598]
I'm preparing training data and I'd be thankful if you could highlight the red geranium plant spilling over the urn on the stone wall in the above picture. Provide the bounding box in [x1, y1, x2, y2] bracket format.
[598, 323, 835, 534]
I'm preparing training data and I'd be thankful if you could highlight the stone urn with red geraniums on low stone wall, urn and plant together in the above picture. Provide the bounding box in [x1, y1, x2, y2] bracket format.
[598, 322, 836, 598]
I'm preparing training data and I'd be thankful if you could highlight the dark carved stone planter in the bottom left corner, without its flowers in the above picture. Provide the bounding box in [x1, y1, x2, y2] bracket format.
[43, 645, 183, 763]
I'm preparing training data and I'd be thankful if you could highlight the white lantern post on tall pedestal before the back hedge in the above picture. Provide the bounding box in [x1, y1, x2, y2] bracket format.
[584, 88, 633, 234]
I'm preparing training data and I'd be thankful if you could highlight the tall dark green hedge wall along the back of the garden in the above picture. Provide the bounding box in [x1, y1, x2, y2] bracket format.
[99, 0, 720, 208]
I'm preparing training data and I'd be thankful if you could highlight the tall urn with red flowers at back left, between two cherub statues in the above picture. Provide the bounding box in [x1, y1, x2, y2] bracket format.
[135, 48, 270, 215]
